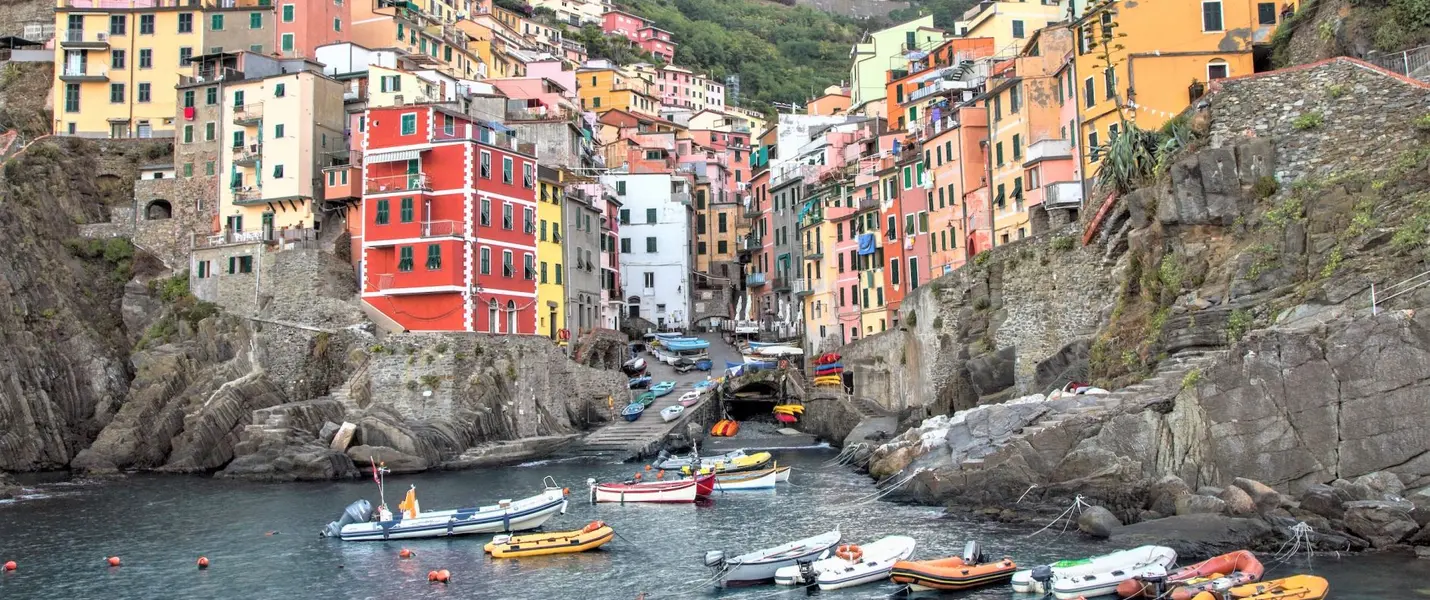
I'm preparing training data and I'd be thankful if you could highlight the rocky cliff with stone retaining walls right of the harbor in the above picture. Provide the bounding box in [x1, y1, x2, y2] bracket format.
[845, 60, 1430, 547]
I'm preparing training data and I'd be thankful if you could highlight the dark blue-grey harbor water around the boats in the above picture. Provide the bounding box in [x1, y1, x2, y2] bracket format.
[0, 449, 1430, 600]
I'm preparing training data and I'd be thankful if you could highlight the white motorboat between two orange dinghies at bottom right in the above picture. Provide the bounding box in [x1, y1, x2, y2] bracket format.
[1012, 546, 1177, 600]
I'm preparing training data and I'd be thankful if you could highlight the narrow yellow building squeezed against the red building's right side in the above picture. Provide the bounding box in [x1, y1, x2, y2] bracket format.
[536, 166, 566, 340]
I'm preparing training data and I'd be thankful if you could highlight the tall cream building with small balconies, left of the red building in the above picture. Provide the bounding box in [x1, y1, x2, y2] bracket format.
[217, 60, 347, 239]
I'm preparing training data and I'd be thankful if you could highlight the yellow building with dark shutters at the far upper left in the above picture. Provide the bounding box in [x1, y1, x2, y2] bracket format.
[53, 0, 275, 137]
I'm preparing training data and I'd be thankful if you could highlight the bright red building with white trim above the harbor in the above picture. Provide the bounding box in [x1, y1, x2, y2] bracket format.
[359, 104, 536, 334]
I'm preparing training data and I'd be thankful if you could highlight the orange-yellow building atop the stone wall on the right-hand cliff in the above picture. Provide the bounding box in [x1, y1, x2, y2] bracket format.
[1074, 0, 1277, 177]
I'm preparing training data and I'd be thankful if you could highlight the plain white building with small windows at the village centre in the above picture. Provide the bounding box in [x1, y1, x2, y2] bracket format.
[602, 173, 694, 329]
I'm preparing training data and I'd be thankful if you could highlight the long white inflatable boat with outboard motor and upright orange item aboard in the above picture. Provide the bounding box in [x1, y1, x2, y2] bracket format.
[323, 477, 566, 541]
